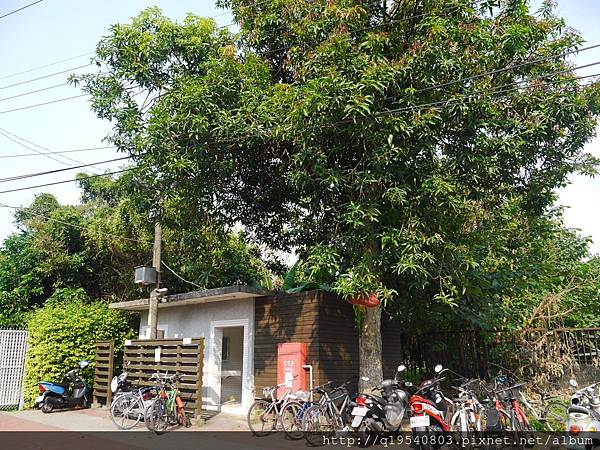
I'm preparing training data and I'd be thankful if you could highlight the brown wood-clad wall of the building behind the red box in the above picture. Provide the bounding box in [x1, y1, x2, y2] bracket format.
[254, 291, 401, 395]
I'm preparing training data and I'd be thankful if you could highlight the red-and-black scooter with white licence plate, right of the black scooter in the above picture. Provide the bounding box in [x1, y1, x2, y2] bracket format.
[408, 364, 454, 450]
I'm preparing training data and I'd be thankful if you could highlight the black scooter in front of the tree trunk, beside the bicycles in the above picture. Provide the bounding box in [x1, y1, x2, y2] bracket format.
[351, 365, 412, 446]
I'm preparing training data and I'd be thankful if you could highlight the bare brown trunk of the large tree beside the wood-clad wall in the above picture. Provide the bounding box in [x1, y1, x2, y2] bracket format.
[358, 304, 383, 392]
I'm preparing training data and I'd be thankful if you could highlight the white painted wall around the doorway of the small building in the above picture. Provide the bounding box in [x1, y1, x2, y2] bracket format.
[139, 299, 254, 412]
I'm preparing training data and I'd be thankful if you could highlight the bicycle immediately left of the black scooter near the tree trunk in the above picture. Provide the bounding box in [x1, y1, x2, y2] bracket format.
[302, 381, 352, 447]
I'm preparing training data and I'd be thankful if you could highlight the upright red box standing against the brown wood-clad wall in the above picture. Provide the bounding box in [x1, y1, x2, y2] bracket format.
[277, 342, 307, 398]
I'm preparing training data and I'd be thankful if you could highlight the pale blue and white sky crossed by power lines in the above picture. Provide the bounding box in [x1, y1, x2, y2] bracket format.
[0, 0, 600, 252]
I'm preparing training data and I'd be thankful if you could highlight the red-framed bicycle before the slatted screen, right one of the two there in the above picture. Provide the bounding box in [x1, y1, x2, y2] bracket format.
[145, 373, 191, 434]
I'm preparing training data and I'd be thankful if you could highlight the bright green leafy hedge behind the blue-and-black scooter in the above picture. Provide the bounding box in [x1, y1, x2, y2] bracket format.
[25, 296, 136, 406]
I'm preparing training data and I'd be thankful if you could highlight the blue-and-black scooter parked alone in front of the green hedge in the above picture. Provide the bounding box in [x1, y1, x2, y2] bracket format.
[35, 361, 89, 413]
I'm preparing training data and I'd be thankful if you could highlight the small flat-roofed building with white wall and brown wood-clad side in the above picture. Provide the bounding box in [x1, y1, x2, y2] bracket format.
[111, 286, 401, 413]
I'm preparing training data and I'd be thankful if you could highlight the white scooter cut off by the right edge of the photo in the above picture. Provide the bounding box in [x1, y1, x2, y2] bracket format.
[565, 379, 600, 450]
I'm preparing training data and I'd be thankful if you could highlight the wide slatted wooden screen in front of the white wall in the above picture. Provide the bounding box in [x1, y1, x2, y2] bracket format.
[123, 338, 204, 417]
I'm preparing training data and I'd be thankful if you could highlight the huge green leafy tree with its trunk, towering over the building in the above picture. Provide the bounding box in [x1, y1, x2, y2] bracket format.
[74, 0, 598, 386]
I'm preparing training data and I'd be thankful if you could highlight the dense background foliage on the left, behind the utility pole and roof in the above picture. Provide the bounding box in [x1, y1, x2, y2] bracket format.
[0, 172, 268, 328]
